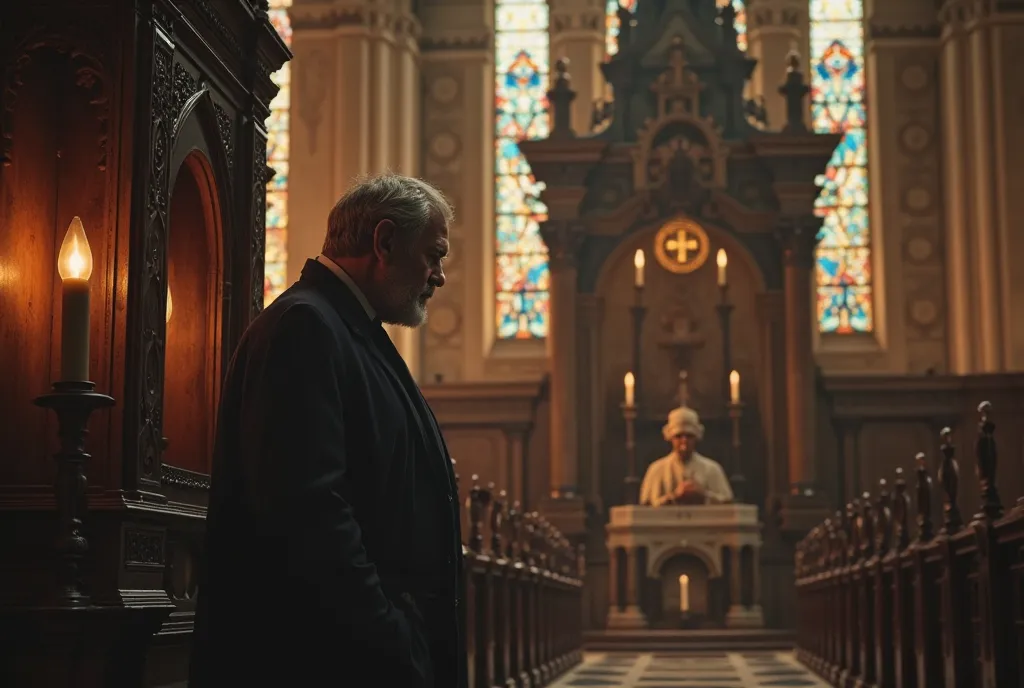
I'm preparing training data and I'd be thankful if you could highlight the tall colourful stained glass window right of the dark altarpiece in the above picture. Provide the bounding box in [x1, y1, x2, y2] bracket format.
[810, 0, 874, 334]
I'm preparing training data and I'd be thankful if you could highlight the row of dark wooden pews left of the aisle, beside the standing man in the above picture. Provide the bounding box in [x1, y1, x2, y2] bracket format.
[462, 466, 584, 688]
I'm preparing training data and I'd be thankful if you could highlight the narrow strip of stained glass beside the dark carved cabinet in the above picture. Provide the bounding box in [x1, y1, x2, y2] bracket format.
[263, 0, 292, 304]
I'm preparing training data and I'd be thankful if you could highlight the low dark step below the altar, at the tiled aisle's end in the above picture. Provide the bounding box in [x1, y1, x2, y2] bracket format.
[583, 629, 797, 652]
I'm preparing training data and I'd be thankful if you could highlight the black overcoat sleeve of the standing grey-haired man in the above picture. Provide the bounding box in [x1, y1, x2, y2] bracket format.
[249, 304, 430, 688]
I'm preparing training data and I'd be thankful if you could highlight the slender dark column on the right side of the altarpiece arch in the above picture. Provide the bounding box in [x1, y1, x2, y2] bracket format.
[780, 216, 821, 496]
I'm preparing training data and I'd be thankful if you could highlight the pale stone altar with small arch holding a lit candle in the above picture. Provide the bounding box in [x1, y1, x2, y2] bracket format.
[606, 504, 764, 629]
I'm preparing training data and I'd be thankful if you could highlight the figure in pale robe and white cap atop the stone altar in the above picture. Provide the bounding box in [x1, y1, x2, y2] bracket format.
[640, 407, 732, 507]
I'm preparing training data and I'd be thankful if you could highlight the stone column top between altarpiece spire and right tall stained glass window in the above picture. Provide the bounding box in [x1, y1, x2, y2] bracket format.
[746, 0, 810, 130]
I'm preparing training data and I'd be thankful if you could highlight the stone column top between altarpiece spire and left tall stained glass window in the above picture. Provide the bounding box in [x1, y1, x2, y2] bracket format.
[549, 0, 606, 135]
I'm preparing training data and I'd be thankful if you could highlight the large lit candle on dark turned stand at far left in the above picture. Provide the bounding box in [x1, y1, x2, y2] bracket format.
[57, 215, 92, 382]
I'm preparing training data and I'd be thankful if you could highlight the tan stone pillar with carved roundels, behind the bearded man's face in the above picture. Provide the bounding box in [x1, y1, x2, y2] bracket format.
[418, 0, 495, 381]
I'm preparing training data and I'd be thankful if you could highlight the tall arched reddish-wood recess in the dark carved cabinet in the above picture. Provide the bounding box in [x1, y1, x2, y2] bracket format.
[164, 151, 223, 474]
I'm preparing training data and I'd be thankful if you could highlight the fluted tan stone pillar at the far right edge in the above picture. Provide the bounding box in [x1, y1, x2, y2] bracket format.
[939, 0, 1024, 374]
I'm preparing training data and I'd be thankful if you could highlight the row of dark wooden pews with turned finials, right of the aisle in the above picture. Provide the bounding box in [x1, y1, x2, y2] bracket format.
[796, 402, 1024, 688]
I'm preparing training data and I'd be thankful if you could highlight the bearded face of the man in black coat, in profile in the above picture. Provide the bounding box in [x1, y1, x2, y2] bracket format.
[370, 218, 449, 328]
